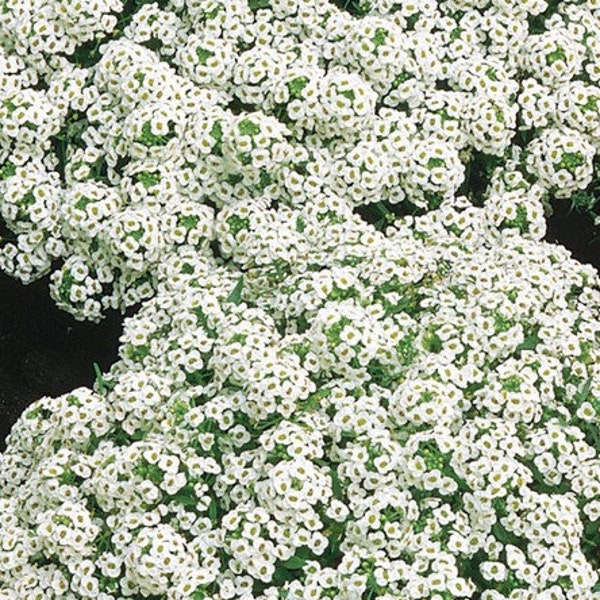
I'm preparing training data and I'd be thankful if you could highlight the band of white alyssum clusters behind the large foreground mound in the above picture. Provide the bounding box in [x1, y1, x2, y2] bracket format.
[0, 0, 600, 320]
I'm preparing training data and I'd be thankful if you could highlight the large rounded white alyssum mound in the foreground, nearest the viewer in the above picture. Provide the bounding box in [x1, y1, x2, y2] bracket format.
[0, 196, 600, 600]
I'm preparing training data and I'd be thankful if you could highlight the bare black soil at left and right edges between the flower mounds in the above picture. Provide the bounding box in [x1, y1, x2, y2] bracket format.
[0, 209, 600, 451]
